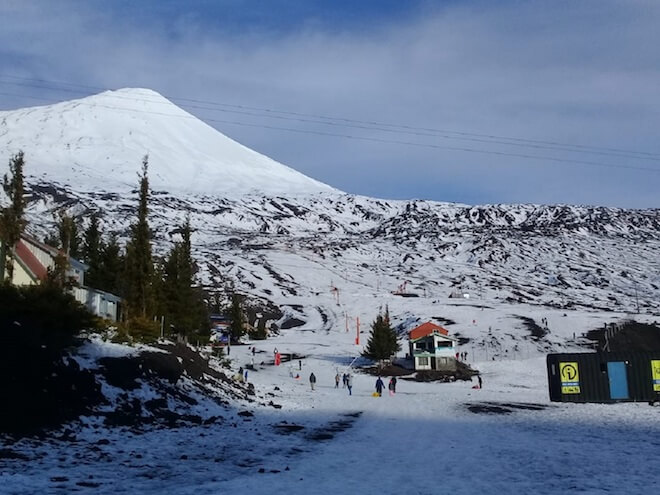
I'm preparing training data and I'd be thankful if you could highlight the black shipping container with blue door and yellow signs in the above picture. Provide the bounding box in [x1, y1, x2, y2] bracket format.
[546, 351, 660, 403]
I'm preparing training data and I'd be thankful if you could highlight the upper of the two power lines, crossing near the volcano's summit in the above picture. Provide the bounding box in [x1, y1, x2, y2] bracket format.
[0, 74, 660, 161]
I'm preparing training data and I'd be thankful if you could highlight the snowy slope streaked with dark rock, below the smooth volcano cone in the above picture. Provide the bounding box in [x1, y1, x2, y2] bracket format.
[20, 185, 660, 344]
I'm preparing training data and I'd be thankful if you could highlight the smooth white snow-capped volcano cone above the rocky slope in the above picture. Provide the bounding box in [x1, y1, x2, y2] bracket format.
[0, 89, 336, 196]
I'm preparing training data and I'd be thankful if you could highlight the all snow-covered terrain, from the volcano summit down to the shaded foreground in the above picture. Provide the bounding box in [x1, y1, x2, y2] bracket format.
[0, 90, 660, 495]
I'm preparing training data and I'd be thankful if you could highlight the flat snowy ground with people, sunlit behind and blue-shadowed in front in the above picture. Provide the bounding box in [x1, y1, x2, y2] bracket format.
[0, 305, 660, 494]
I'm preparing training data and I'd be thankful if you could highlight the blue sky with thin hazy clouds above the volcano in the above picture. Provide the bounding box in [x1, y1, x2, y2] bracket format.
[0, 0, 660, 207]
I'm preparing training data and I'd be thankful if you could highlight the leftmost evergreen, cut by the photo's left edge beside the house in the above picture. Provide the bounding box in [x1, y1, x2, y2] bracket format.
[0, 151, 27, 282]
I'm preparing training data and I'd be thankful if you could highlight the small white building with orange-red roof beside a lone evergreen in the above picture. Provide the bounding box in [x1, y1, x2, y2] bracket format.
[408, 321, 458, 371]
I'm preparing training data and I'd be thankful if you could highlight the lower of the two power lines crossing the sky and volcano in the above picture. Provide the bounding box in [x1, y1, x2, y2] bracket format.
[0, 83, 660, 172]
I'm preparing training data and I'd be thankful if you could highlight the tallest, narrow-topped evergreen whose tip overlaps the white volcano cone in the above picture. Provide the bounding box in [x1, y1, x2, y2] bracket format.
[124, 156, 154, 318]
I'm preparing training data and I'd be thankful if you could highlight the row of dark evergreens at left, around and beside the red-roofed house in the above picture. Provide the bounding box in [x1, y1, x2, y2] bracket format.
[0, 151, 209, 341]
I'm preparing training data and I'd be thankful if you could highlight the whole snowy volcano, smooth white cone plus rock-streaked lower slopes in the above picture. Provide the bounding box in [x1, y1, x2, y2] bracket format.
[0, 90, 660, 349]
